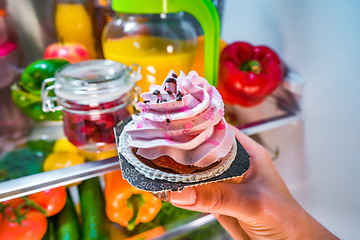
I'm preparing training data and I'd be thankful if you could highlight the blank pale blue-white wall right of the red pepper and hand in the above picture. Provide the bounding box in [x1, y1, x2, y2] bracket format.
[221, 0, 360, 239]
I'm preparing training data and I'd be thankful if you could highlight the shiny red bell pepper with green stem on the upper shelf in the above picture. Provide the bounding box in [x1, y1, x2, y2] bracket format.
[218, 42, 283, 107]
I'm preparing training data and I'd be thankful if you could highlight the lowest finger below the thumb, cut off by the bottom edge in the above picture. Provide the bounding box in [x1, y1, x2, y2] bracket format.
[214, 214, 250, 239]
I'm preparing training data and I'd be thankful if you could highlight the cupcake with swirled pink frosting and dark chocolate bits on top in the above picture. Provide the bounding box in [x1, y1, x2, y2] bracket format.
[118, 71, 237, 182]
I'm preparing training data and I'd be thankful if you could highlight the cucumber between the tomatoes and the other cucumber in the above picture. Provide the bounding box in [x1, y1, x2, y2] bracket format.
[51, 190, 81, 240]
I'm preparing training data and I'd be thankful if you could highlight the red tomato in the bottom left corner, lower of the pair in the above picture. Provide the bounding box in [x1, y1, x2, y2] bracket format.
[0, 208, 47, 240]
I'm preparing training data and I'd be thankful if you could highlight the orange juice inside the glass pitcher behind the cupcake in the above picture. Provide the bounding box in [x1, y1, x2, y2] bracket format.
[103, 36, 195, 92]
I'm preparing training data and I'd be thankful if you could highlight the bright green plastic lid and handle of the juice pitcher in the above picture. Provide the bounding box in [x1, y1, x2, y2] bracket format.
[112, 0, 220, 86]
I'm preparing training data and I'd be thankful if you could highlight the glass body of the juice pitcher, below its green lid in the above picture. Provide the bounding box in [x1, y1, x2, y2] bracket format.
[102, 12, 197, 92]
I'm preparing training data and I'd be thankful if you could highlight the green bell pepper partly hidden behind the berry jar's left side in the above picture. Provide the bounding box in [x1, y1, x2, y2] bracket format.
[11, 59, 69, 121]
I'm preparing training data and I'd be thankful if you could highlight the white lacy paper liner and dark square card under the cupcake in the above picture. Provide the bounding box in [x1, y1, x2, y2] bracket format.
[115, 117, 250, 193]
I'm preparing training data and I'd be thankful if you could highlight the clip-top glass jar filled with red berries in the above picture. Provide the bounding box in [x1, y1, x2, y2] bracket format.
[41, 59, 141, 152]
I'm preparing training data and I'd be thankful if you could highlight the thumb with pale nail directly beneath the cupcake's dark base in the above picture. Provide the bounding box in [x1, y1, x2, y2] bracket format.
[169, 183, 250, 217]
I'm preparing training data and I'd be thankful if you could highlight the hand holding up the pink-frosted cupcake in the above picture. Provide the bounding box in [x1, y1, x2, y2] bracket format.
[169, 127, 337, 239]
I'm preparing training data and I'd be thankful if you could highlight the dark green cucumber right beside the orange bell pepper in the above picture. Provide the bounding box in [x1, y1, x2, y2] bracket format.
[78, 177, 109, 240]
